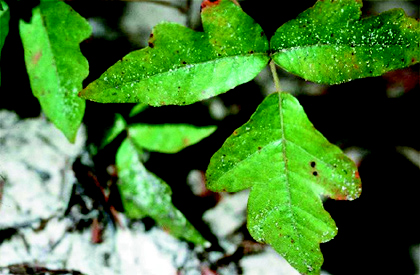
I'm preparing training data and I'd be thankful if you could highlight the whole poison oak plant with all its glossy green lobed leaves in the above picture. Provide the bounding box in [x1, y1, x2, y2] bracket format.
[0, 0, 420, 274]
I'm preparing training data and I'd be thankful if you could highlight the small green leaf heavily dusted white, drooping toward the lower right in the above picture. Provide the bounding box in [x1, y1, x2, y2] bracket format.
[116, 139, 208, 246]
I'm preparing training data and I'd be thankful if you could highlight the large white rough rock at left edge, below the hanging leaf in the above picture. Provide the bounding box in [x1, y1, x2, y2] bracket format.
[0, 110, 86, 229]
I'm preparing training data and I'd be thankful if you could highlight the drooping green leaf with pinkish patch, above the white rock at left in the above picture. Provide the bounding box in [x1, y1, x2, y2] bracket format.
[19, 1, 91, 142]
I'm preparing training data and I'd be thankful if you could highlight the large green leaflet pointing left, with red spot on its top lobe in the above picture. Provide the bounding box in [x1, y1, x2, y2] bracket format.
[81, 0, 269, 106]
